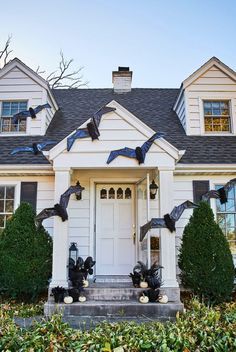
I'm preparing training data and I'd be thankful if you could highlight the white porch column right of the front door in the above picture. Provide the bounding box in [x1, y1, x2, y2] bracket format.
[159, 168, 179, 287]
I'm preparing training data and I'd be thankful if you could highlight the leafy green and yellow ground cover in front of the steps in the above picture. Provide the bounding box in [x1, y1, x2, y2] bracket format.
[0, 300, 236, 352]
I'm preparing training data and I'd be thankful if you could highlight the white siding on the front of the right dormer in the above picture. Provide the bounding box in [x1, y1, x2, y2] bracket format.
[185, 66, 236, 135]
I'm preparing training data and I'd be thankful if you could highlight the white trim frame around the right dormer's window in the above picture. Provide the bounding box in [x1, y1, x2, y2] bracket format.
[199, 95, 235, 137]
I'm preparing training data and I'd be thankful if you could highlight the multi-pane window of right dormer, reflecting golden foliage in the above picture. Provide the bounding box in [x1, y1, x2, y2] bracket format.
[203, 100, 231, 133]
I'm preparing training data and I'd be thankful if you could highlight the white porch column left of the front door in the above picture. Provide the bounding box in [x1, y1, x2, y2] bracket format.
[50, 168, 71, 287]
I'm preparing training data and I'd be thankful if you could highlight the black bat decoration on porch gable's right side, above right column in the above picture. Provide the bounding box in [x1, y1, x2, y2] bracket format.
[107, 132, 165, 164]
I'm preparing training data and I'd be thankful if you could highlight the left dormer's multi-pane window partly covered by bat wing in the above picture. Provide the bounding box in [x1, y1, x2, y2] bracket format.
[0, 101, 27, 133]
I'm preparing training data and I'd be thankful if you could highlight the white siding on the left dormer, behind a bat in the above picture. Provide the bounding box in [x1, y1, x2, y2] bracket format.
[0, 67, 55, 136]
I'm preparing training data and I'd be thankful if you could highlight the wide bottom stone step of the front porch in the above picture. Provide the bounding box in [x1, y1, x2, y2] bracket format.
[44, 300, 183, 320]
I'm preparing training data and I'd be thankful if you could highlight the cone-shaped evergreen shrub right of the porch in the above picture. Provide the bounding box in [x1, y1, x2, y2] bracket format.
[179, 202, 234, 304]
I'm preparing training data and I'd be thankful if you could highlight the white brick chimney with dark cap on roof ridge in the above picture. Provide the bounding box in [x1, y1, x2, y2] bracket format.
[112, 67, 133, 94]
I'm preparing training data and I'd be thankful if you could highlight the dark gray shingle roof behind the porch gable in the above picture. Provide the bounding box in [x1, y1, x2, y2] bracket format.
[0, 88, 236, 164]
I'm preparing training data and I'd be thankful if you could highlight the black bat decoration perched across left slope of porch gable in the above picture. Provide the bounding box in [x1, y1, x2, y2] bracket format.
[67, 106, 116, 151]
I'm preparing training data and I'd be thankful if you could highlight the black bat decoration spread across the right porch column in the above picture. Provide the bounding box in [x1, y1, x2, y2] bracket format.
[140, 200, 198, 241]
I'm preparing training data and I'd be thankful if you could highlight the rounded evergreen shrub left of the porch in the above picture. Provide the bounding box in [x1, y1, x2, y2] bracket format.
[0, 203, 52, 300]
